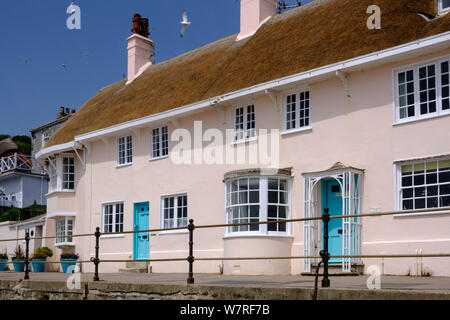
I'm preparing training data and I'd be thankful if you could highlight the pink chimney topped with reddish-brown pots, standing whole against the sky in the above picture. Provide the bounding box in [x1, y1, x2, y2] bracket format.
[127, 13, 154, 84]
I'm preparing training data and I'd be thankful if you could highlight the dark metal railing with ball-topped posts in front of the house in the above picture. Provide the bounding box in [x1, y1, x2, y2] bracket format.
[0, 207, 450, 297]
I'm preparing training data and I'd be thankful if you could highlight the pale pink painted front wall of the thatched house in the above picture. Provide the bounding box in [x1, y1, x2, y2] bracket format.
[47, 50, 450, 276]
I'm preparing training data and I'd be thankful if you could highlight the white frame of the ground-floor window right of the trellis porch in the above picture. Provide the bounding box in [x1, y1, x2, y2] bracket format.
[394, 156, 450, 216]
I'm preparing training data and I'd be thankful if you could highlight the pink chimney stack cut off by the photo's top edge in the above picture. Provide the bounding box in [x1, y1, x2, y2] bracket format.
[236, 0, 278, 41]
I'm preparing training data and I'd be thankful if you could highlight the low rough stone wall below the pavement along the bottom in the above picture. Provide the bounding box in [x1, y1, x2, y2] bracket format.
[0, 280, 450, 300]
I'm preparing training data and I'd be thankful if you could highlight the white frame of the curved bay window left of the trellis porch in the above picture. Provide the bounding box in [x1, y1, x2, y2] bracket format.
[224, 175, 292, 237]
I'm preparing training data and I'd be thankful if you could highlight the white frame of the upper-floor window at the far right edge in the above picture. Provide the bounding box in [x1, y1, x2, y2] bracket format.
[392, 55, 450, 125]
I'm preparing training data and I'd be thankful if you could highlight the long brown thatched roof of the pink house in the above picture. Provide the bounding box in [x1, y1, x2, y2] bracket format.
[47, 0, 450, 147]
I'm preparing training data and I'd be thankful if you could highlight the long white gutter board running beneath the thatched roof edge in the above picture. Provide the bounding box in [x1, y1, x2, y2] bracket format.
[36, 31, 450, 158]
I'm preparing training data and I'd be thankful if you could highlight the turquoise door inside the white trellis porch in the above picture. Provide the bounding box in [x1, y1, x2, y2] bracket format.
[322, 179, 342, 262]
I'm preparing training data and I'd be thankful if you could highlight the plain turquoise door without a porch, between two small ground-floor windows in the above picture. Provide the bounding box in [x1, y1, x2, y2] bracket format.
[133, 202, 150, 260]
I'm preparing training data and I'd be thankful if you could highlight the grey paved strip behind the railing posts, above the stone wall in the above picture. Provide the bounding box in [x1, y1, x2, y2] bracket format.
[0, 271, 450, 292]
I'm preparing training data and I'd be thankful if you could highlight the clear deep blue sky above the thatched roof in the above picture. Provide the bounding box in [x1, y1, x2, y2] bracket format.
[0, 0, 311, 136]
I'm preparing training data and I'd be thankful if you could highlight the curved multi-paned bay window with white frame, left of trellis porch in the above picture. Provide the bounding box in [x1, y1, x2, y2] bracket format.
[226, 176, 290, 235]
